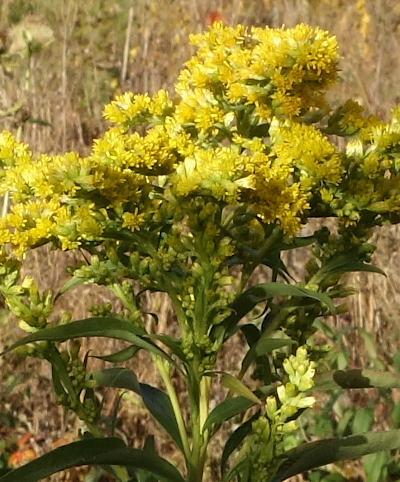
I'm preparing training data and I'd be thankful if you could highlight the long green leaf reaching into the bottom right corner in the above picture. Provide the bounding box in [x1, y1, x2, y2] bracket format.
[272, 430, 400, 482]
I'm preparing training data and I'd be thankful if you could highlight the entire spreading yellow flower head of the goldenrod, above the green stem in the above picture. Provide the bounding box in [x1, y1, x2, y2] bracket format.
[0, 22, 400, 256]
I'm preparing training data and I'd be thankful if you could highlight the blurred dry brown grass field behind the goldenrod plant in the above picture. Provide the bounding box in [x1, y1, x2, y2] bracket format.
[0, 0, 400, 482]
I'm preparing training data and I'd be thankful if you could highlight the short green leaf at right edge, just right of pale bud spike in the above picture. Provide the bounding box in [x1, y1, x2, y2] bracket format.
[313, 369, 400, 390]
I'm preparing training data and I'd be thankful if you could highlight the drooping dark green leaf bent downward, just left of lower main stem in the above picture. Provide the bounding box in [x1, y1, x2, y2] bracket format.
[92, 368, 182, 449]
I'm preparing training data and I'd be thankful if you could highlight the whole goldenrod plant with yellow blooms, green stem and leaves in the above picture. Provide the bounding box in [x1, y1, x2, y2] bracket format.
[0, 22, 400, 482]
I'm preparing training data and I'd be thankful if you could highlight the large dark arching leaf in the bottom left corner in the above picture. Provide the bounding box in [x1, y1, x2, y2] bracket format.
[0, 438, 184, 482]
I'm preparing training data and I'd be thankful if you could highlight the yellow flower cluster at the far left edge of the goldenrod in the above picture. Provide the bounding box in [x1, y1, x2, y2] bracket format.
[0, 135, 146, 256]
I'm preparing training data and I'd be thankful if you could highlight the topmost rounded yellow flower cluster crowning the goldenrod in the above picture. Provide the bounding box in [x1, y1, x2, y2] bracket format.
[176, 22, 338, 122]
